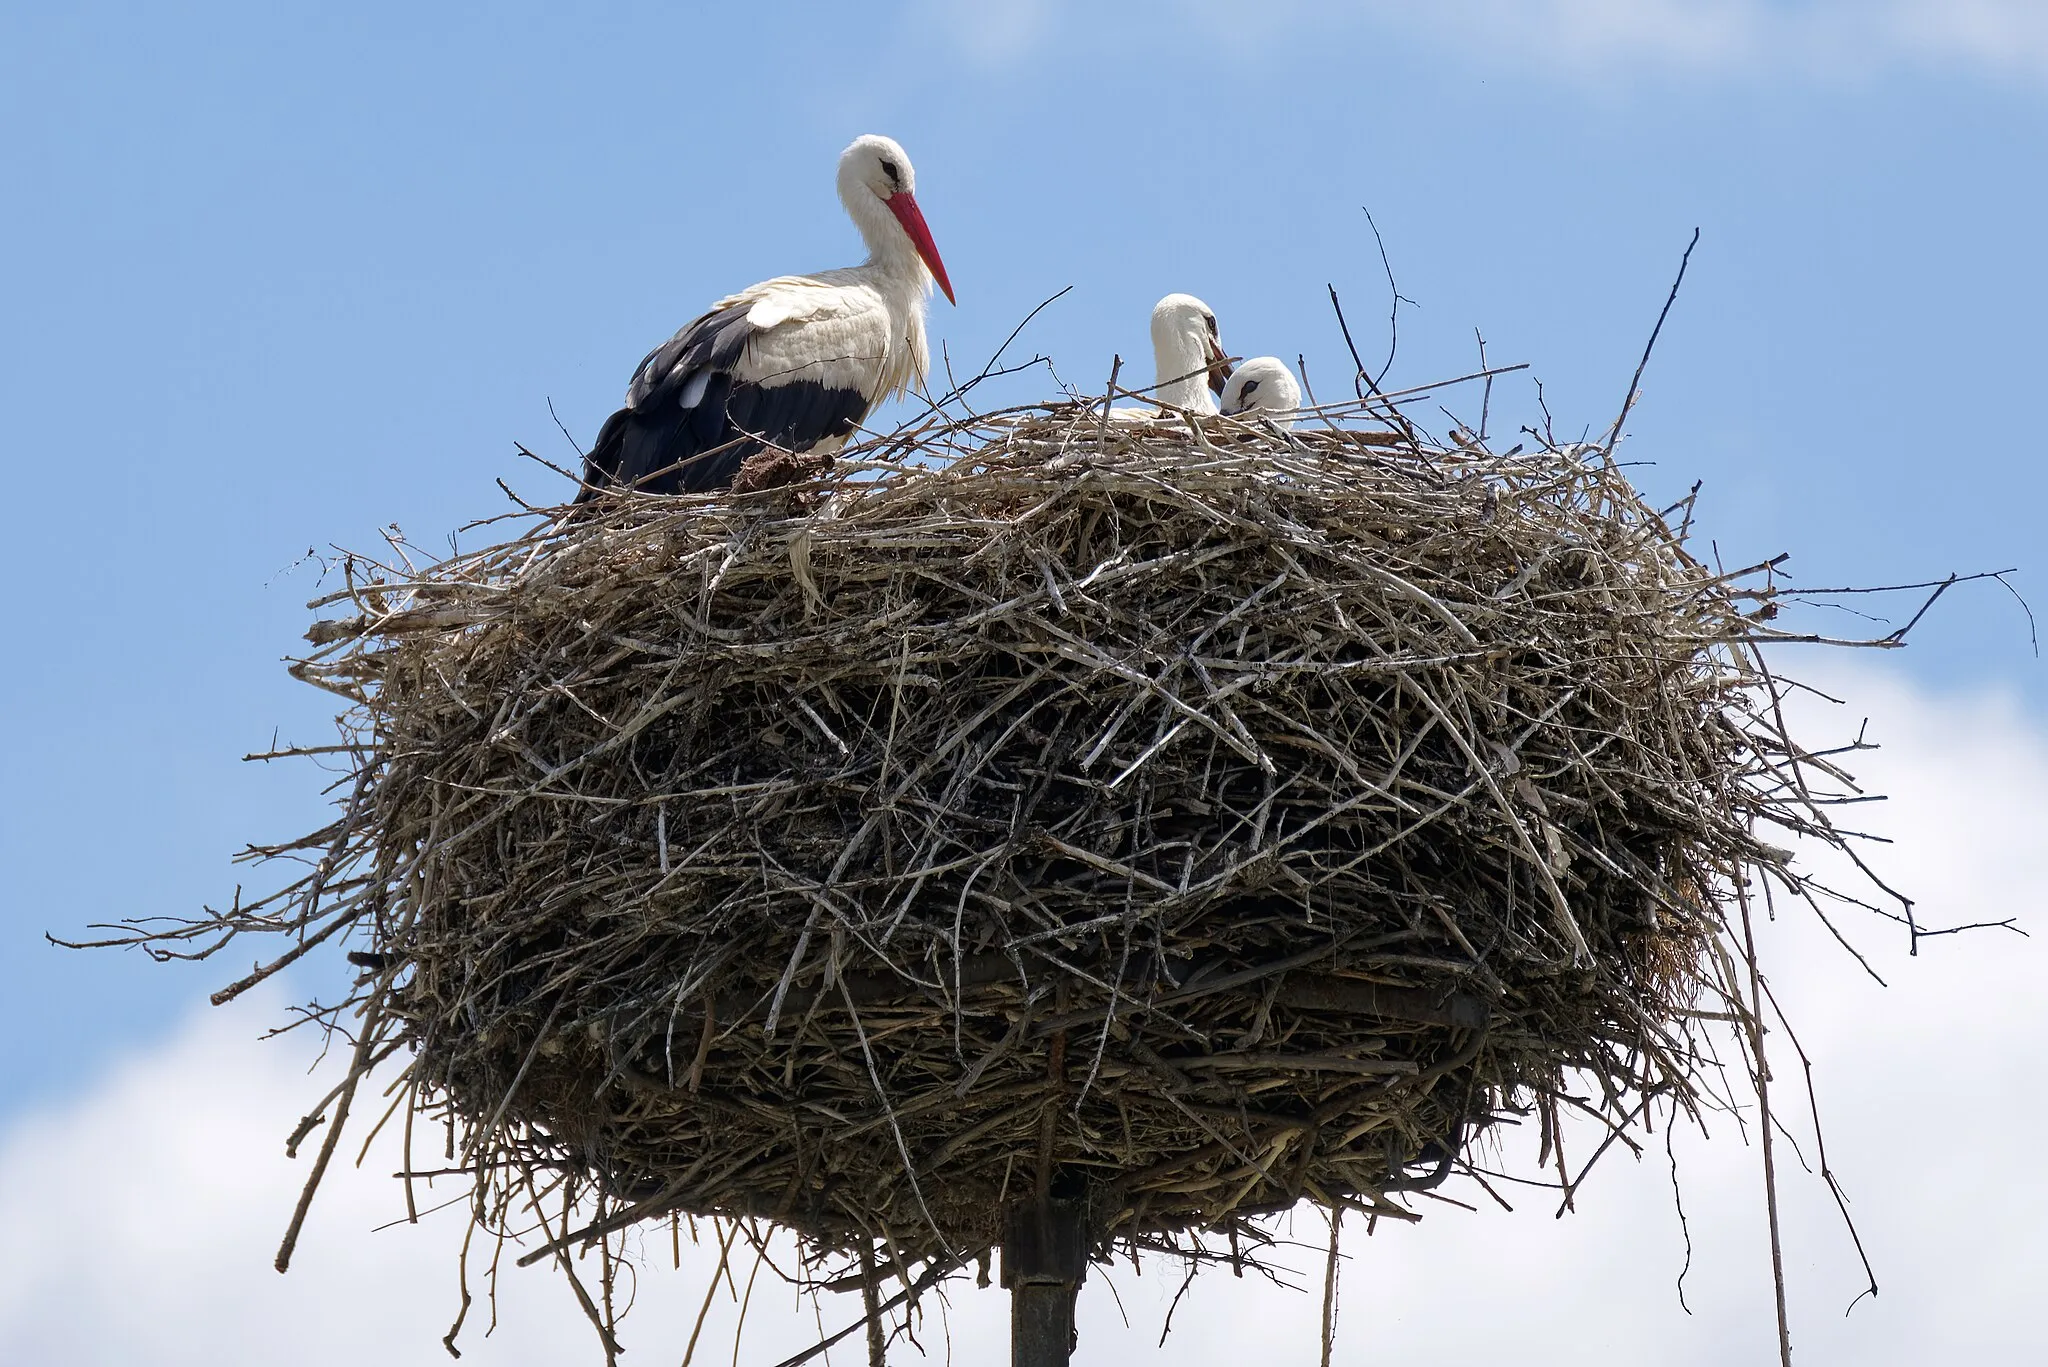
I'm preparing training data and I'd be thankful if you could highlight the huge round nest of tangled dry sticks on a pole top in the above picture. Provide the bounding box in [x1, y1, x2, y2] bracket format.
[144, 406, 1859, 1295]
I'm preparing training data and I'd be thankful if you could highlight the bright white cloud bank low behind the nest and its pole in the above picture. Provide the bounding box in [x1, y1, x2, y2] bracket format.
[0, 668, 2048, 1367]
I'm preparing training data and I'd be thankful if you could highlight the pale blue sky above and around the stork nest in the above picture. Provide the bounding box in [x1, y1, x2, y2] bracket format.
[0, 0, 2048, 1360]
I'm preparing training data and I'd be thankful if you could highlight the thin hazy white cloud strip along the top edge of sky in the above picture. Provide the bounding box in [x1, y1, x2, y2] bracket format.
[920, 0, 2048, 80]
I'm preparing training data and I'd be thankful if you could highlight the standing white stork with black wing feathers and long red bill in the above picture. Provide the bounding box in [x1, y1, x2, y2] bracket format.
[575, 133, 952, 502]
